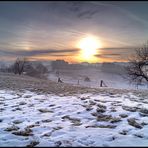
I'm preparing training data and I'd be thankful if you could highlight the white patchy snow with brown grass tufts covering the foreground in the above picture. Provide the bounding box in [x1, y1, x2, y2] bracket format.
[0, 90, 148, 146]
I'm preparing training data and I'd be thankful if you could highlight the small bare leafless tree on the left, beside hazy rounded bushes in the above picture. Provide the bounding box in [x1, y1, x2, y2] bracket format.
[12, 58, 27, 75]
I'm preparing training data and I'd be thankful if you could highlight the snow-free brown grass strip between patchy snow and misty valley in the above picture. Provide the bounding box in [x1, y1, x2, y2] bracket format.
[0, 73, 148, 98]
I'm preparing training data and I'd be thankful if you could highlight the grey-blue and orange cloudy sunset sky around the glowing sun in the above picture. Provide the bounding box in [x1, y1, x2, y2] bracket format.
[0, 1, 148, 63]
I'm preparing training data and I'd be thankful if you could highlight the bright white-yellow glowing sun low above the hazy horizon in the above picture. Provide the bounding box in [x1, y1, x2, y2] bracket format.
[78, 36, 101, 62]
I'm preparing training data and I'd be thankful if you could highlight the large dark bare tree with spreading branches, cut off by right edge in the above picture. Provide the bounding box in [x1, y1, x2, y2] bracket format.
[126, 42, 148, 85]
